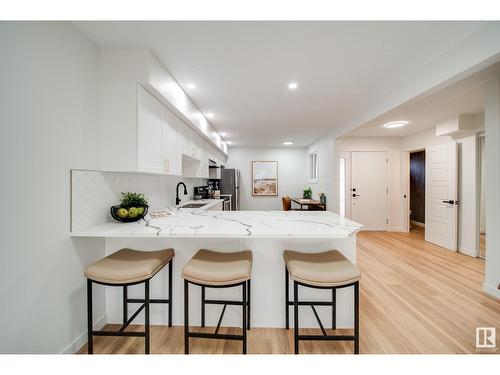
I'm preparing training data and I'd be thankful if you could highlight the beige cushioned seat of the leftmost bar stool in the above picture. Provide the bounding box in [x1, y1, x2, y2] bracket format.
[85, 249, 175, 284]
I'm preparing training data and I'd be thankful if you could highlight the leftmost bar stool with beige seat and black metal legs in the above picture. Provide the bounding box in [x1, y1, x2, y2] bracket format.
[85, 249, 175, 354]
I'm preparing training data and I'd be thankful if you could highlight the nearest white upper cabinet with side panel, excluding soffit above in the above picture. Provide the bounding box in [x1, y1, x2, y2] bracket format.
[101, 84, 182, 176]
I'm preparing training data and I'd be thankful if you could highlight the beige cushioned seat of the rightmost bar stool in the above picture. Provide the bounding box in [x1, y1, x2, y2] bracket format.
[283, 250, 361, 287]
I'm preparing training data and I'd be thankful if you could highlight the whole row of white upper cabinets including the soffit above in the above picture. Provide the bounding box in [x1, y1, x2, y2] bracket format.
[100, 48, 226, 178]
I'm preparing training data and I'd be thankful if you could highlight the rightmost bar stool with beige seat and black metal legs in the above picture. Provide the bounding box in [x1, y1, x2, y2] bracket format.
[283, 250, 361, 354]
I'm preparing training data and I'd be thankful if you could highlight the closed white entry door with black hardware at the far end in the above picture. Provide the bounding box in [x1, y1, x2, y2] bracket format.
[351, 151, 388, 230]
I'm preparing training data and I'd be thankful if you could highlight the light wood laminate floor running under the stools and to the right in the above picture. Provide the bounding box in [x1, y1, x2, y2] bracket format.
[79, 230, 500, 354]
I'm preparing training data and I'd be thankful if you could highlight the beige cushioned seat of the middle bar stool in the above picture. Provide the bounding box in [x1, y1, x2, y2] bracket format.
[182, 249, 252, 285]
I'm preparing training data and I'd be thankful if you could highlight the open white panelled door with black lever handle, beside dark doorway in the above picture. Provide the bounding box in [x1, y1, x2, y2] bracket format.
[425, 142, 458, 251]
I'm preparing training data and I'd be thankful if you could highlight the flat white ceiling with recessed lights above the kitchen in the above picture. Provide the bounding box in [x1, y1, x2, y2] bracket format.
[75, 21, 484, 147]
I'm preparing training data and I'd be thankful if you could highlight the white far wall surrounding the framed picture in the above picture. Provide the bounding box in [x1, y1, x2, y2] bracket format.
[226, 147, 308, 211]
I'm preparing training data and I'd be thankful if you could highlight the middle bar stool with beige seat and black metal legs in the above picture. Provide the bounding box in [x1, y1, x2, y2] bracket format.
[182, 249, 252, 354]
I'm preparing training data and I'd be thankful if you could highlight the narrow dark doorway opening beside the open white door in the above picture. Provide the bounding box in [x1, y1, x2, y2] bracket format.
[410, 150, 425, 234]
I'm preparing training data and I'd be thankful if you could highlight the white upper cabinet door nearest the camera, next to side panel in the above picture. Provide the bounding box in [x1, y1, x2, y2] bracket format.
[138, 86, 165, 172]
